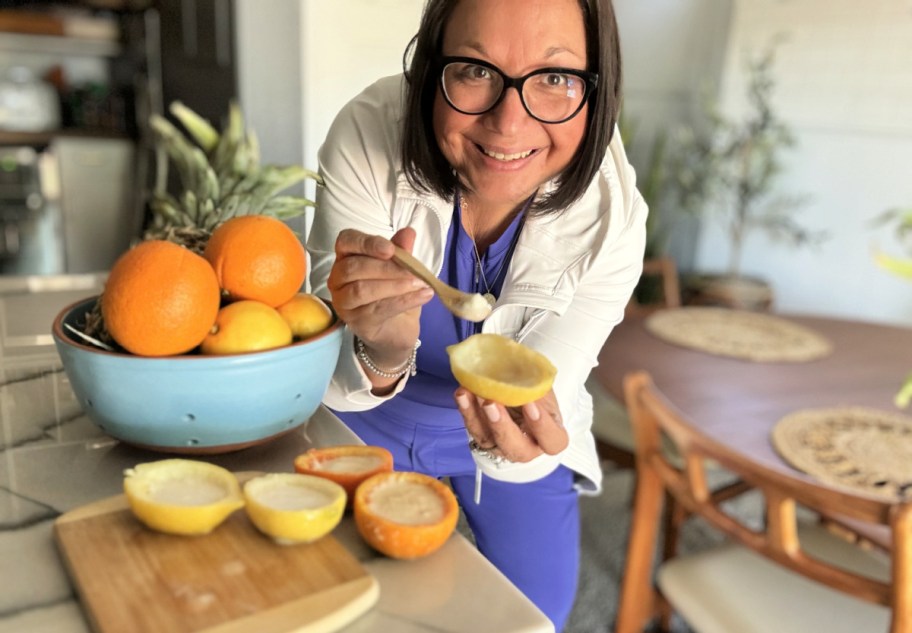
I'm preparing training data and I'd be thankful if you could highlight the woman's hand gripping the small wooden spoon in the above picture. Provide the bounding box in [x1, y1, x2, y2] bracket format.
[327, 228, 434, 379]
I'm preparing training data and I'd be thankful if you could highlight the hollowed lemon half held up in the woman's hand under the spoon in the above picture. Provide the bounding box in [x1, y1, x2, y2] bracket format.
[447, 334, 557, 407]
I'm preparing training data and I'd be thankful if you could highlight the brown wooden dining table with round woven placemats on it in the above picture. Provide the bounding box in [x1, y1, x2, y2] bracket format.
[594, 315, 912, 477]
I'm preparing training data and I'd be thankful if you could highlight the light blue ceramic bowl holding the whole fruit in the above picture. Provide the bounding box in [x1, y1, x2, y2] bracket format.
[53, 297, 344, 454]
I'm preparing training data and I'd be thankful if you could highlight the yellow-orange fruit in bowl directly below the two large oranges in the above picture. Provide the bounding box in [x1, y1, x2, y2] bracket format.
[200, 301, 291, 354]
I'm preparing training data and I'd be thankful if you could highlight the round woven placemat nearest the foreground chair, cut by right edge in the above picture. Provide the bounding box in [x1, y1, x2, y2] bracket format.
[772, 407, 912, 499]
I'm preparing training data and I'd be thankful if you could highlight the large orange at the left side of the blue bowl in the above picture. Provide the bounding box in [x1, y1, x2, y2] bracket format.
[101, 240, 220, 356]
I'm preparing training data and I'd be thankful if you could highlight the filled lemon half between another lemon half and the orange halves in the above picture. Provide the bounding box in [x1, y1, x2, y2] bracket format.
[244, 473, 346, 545]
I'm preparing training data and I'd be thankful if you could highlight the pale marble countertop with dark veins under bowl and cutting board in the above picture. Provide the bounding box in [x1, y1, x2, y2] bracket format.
[0, 278, 553, 633]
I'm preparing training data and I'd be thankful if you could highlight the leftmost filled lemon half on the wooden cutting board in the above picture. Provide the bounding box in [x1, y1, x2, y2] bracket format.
[124, 459, 244, 534]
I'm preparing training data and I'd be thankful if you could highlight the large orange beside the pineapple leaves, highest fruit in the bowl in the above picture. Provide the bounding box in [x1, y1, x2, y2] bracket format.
[203, 215, 307, 308]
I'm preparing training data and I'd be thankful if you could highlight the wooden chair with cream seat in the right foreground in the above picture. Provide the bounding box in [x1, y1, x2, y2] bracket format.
[615, 372, 912, 633]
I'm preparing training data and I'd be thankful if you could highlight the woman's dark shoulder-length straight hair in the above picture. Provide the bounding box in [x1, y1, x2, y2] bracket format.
[401, 0, 621, 213]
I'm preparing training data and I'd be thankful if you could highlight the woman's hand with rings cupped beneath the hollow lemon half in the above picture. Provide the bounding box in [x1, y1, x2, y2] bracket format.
[454, 387, 570, 462]
